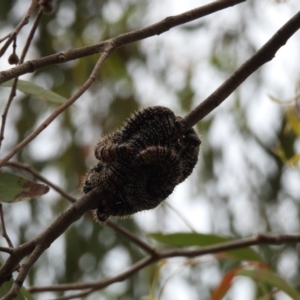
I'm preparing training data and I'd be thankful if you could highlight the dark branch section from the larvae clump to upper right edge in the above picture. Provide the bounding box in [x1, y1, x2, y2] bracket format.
[182, 12, 300, 129]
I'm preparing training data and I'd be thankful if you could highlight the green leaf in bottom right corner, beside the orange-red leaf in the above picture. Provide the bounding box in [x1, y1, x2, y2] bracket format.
[236, 269, 300, 300]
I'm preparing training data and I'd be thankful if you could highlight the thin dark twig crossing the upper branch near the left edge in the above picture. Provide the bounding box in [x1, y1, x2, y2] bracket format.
[0, 10, 44, 149]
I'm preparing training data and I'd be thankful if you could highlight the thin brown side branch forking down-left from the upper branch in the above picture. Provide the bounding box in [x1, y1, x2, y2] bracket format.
[0, 44, 114, 167]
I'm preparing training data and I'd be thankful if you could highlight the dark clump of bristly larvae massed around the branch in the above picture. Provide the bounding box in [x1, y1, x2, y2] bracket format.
[83, 106, 201, 222]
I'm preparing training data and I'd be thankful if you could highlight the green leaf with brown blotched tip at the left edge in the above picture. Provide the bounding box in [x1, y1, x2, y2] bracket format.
[0, 172, 49, 203]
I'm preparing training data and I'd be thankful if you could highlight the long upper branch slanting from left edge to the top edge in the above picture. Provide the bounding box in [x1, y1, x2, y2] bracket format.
[0, 0, 246, 84]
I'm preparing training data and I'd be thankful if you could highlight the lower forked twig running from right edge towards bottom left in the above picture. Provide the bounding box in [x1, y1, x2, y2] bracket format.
[28, 234, 300, 299]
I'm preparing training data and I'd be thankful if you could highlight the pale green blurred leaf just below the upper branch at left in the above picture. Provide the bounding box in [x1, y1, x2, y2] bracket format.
[1, 79, 67, 104]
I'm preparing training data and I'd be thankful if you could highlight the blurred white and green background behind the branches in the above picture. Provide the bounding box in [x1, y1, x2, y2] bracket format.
[0, 0, 300, 300]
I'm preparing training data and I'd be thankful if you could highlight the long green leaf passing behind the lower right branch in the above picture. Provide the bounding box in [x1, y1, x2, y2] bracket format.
[149, 233, 263, 262]
